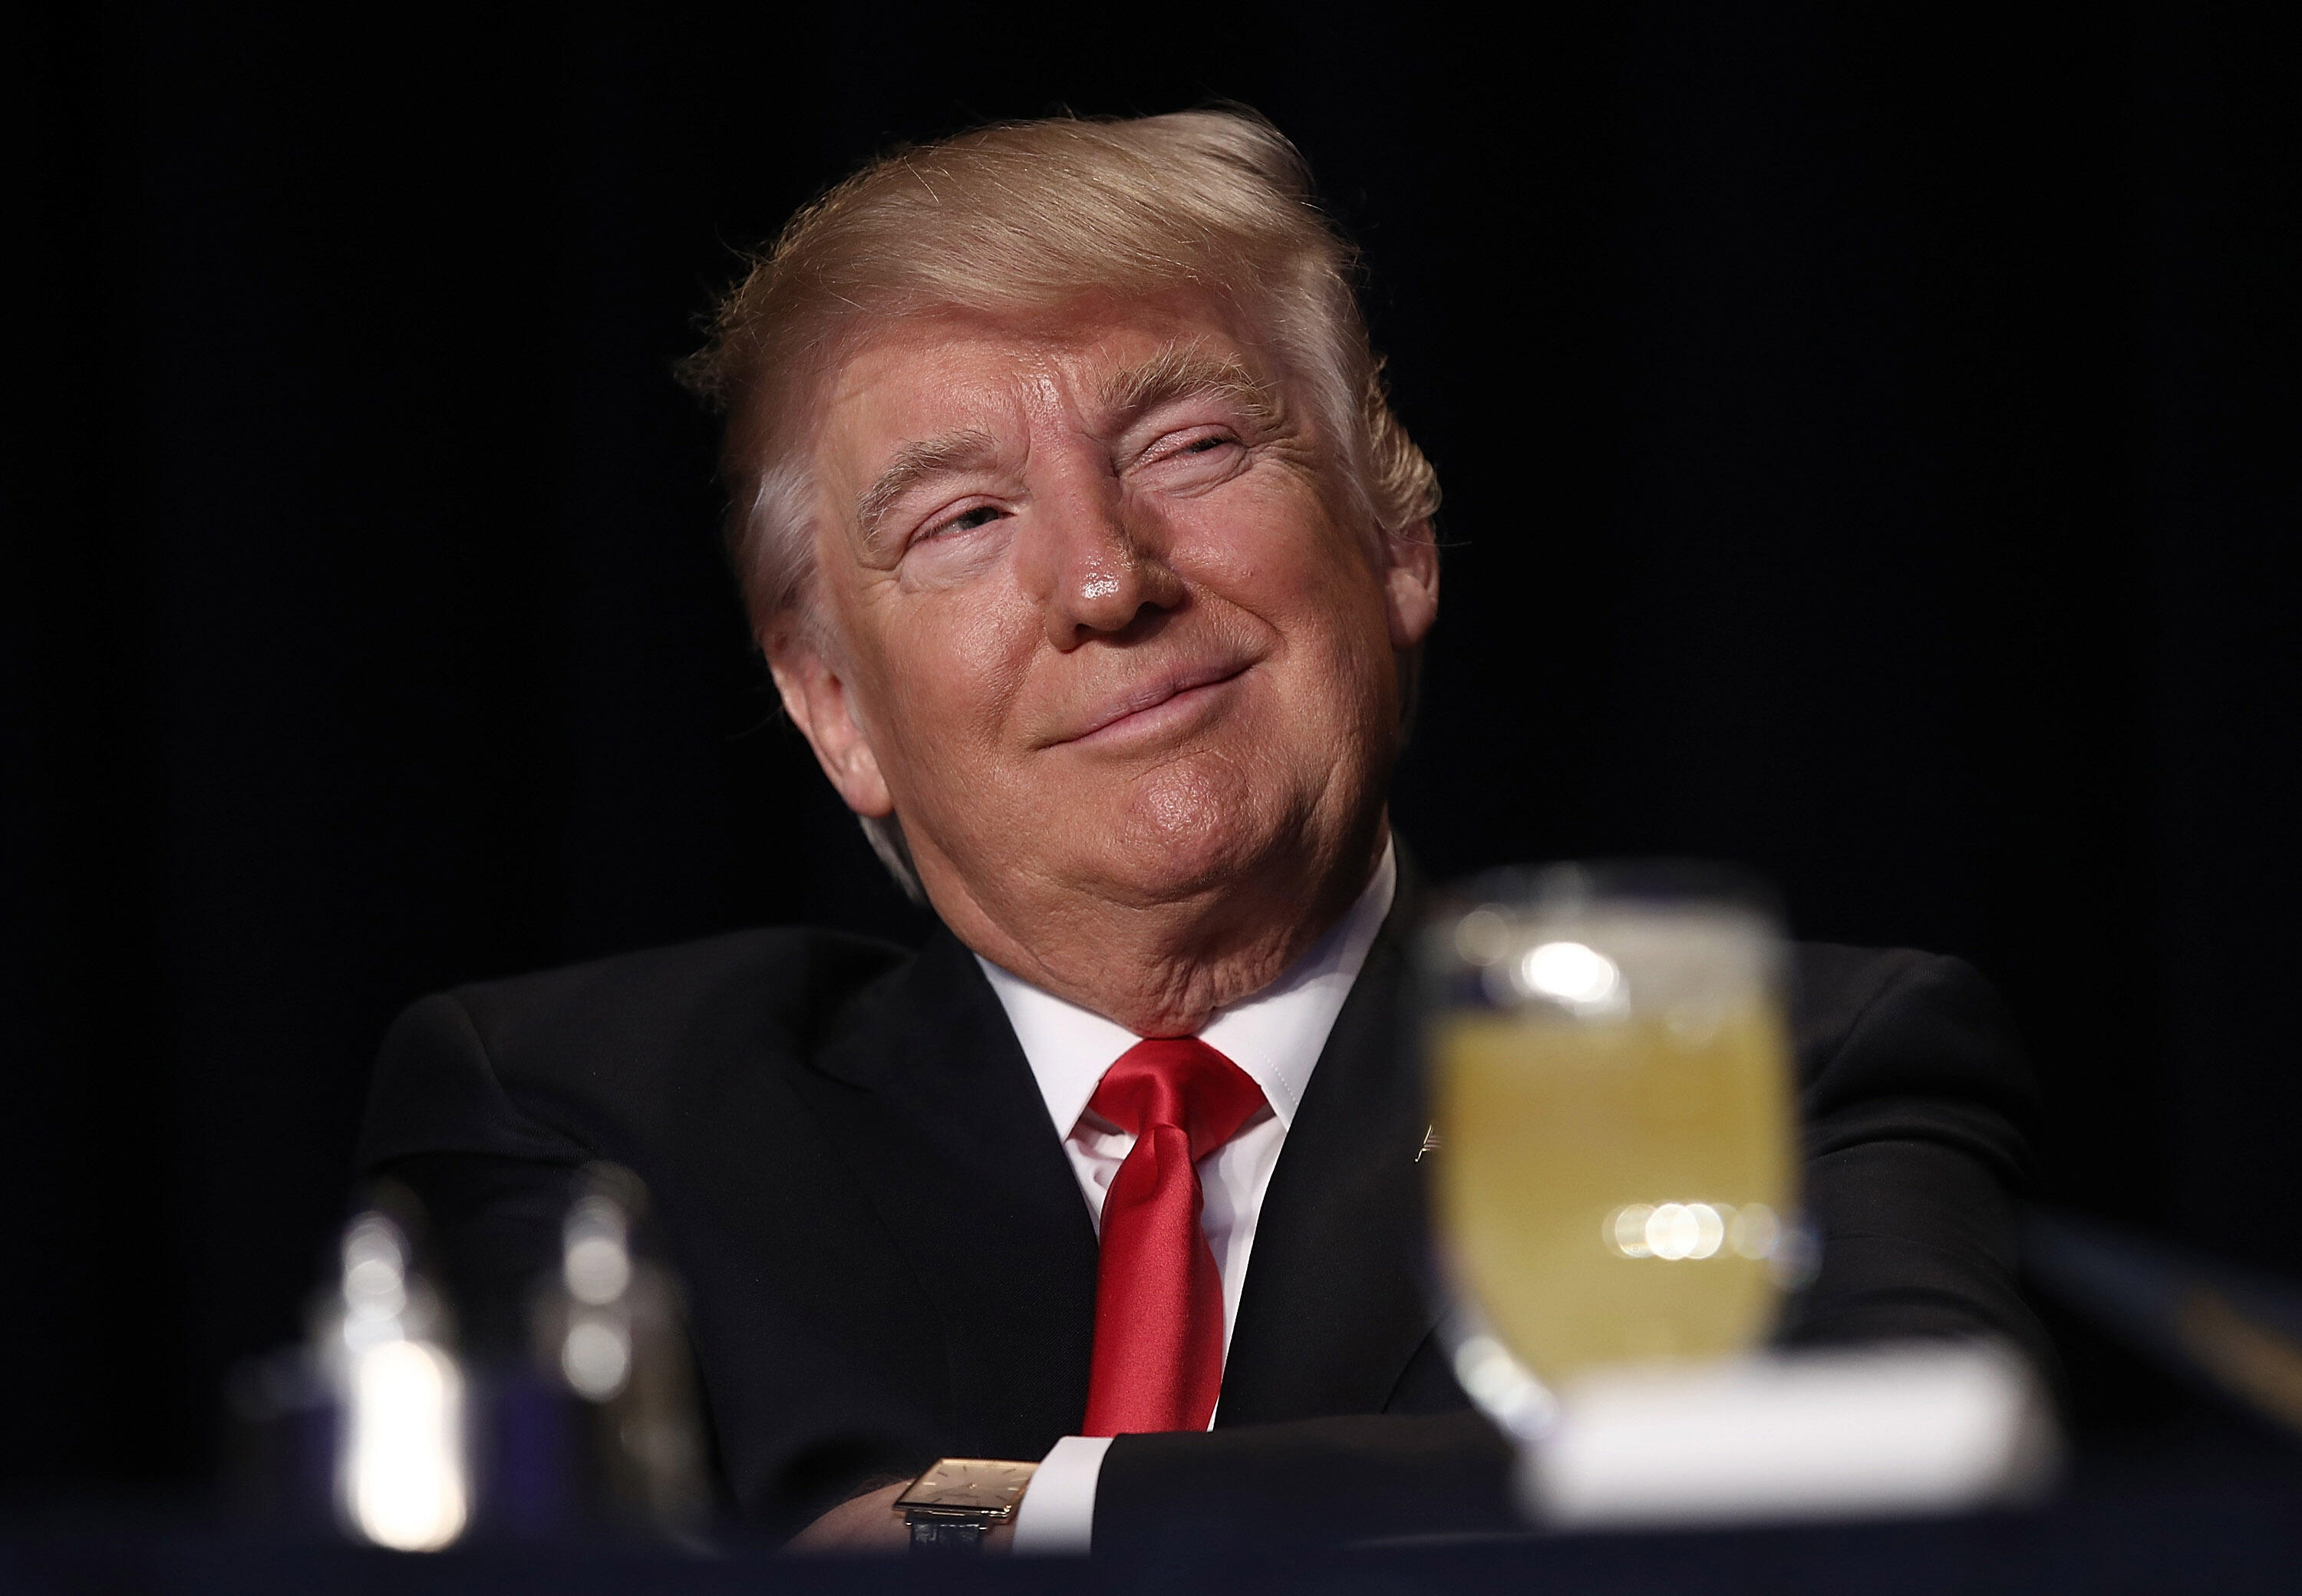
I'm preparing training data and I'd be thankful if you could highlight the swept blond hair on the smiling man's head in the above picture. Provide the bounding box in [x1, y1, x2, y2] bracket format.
[679, 110, 1439, 640]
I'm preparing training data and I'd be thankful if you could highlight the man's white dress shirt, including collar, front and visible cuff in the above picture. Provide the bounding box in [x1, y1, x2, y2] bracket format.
[978, 848, 1397, 1555]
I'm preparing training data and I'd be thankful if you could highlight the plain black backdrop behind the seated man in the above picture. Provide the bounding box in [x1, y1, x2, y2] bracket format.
[0, 2, 2302, 1488]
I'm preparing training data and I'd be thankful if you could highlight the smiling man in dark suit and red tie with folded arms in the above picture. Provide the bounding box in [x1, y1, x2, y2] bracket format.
[364, 113, 2035, 1550]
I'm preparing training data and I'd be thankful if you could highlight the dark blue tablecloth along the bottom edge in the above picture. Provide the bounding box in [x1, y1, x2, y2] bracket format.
[0, 1446, 2302, 1596]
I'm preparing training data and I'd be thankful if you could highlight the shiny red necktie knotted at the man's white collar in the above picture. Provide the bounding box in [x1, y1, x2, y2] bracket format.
[1084, 1037, 1264, 1435]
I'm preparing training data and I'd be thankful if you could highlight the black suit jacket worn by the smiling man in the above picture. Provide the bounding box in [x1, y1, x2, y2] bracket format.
[359, 892, 2042, 1552]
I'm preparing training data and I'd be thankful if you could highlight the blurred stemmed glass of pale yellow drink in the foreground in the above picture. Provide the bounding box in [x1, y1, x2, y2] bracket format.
[1420, 864, 1798, 1437]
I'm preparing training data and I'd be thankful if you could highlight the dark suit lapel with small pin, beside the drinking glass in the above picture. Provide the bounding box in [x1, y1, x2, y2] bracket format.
[1215, 855, 1436, 1428]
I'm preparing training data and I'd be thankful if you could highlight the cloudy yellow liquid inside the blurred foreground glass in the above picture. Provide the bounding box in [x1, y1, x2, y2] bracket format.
[1430, 1004, 1796, 1382]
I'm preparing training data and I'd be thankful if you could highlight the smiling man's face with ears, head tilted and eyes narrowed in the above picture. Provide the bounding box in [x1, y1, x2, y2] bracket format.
[769, 302, 1436, 919]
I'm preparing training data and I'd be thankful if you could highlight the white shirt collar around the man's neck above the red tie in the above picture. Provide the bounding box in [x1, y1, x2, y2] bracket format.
[976, 843, 1400, 1136]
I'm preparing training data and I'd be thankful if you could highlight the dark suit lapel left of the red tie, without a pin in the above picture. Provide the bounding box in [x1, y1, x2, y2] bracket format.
[803, 926, 1096, 1458]
